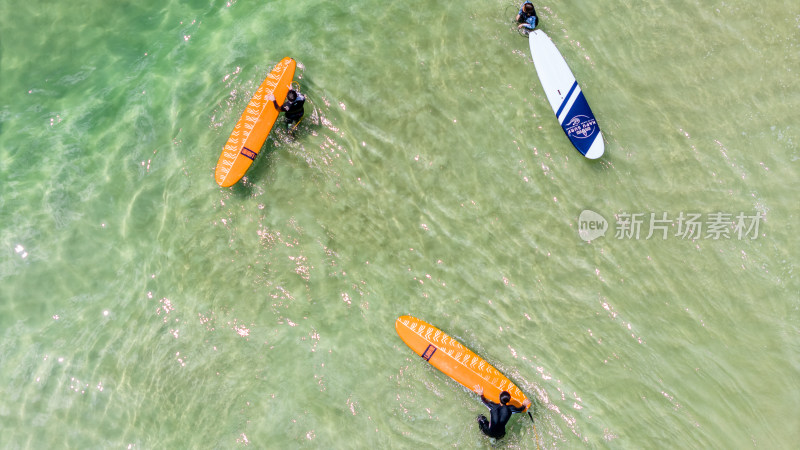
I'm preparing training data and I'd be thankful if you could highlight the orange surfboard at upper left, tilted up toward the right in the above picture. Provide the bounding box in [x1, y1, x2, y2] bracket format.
[214, 56, 297, 187]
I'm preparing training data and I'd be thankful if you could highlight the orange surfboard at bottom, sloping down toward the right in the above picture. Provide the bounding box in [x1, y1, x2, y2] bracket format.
[394, 316, 527, 407]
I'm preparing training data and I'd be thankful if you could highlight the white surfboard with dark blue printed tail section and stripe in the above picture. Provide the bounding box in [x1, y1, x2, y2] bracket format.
[528, 30, 605, 159]
